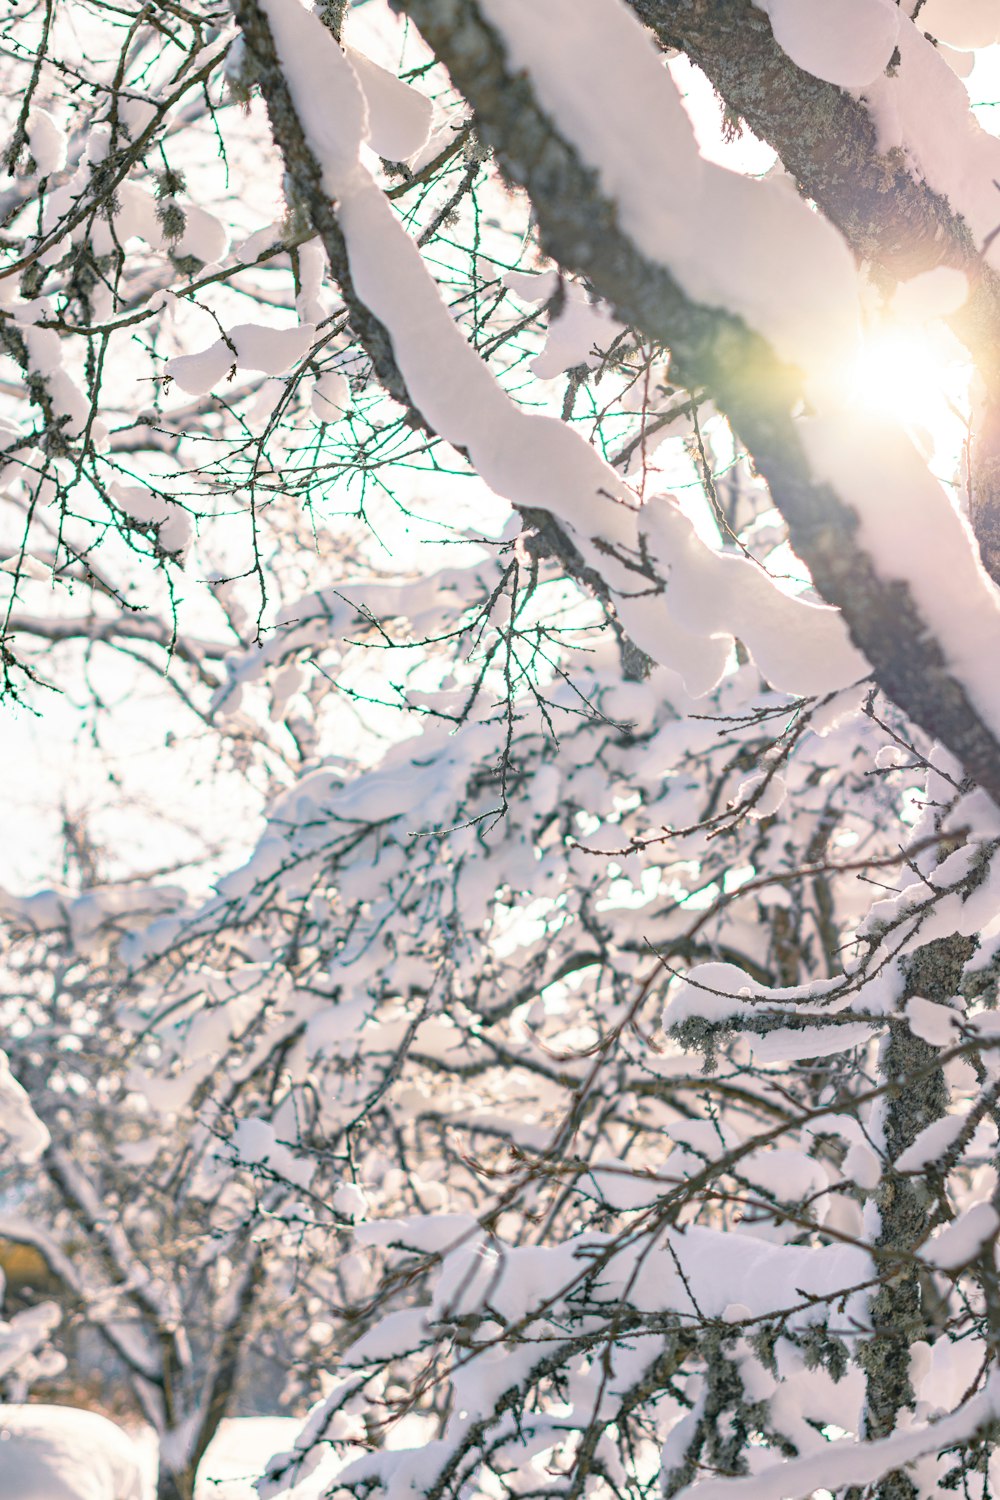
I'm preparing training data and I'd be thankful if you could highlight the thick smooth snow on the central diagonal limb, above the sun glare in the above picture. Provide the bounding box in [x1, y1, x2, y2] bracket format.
[483, 0, 863, 387]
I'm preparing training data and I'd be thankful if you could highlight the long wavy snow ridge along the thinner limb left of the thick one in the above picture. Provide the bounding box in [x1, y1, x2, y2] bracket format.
[235, 0, 867, 693]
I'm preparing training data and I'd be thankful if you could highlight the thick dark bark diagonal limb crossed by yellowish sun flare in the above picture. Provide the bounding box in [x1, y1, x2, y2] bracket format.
[403, 0, 1000, 804]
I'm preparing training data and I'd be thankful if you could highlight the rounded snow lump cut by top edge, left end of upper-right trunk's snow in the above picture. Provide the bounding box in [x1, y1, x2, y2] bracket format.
[754, 0, 900, 89]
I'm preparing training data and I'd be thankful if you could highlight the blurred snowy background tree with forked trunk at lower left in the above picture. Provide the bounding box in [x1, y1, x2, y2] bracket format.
[0, 885, 335, 1500]
